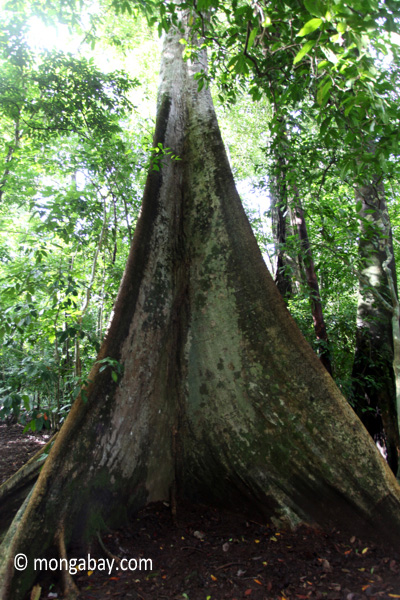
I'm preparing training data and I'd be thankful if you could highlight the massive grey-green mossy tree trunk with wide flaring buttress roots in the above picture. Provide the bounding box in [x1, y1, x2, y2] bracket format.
[0, 21, 400, 600]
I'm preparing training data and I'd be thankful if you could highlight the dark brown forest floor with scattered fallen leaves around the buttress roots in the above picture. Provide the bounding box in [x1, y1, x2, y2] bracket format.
[0, 425, 400, 600]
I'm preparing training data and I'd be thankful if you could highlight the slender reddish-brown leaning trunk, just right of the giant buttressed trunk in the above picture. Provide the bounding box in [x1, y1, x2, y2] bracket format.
[294, 189, 332, 375]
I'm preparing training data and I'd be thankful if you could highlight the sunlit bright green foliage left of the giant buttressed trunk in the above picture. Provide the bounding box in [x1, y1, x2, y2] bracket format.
[0, 9, 152, 430]
